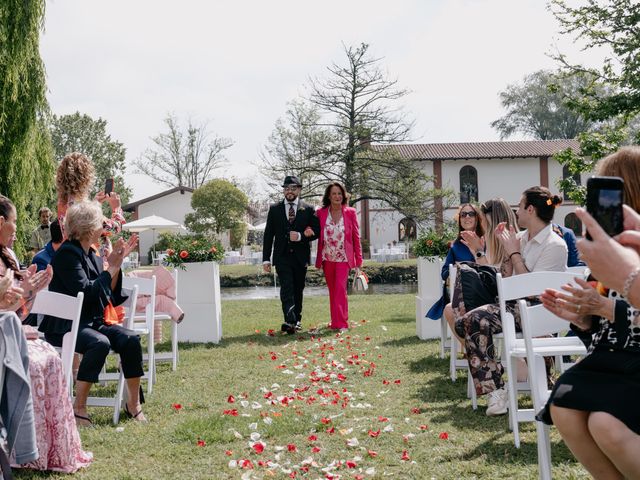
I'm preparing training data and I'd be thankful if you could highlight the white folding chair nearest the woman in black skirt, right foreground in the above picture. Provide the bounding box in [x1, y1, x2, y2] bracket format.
[517, 300, 586, 480]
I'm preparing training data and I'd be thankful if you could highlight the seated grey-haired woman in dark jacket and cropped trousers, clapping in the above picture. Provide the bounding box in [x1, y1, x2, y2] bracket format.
[40, 201, 146, 425]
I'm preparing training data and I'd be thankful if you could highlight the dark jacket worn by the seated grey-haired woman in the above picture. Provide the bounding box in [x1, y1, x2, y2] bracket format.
[40, 240, 127, 334]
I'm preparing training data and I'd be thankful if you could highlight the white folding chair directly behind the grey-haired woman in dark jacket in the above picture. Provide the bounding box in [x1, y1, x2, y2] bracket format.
[30, 290, 84, 396]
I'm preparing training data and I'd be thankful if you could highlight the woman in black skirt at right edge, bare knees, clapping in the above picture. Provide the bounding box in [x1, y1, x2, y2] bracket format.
[538, 147, 640, 478]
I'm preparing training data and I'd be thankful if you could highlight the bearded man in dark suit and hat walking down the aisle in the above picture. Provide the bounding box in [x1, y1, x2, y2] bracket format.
[262, 176, 320, 333]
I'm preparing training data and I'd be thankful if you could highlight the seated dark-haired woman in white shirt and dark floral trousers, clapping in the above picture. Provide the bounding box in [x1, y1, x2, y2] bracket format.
[455, 187, 567, 416]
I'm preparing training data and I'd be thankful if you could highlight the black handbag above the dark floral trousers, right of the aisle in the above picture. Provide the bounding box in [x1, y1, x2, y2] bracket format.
[456, 262, 499, 312]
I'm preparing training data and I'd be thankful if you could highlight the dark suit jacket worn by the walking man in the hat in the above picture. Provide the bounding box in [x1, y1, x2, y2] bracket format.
[262, 200, 320, 267]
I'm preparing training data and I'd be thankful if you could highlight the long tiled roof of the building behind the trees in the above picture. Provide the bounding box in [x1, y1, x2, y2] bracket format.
[371, 140, 580, 160]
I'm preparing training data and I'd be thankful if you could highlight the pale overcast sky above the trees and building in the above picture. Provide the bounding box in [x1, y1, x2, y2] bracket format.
[41, 0, 600, 200]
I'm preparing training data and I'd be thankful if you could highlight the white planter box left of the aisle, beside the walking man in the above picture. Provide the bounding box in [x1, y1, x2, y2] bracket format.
[178, 262, 222, 343]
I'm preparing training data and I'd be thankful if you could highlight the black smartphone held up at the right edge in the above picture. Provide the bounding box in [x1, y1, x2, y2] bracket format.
[587, 176, 624, 240]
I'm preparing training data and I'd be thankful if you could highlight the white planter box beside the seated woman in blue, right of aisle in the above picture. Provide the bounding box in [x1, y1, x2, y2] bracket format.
[416, 257, 444, 340]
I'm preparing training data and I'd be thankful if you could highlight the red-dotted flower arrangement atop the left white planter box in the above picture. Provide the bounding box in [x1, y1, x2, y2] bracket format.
[162, 234, 224, 270]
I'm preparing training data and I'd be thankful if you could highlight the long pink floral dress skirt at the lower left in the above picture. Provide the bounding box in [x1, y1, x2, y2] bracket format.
[19, 340, 93, 473]
